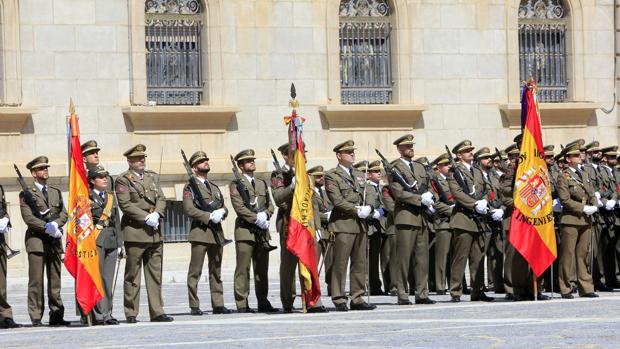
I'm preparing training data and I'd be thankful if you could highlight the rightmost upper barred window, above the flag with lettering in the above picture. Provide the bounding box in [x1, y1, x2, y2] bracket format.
[519, 0, 568, 103]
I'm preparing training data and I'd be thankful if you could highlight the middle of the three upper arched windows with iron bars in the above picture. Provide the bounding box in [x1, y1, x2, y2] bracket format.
[340, 0, 392, 104]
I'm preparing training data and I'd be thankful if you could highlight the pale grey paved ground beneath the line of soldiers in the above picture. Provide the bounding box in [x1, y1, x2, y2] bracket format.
[0, 264, 620, 349]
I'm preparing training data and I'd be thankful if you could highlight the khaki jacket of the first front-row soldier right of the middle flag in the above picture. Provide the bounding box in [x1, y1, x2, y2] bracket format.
[325, 166, 368, 234]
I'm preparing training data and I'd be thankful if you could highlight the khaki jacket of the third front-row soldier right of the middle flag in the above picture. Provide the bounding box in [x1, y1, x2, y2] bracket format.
[448, 162, 491, 232]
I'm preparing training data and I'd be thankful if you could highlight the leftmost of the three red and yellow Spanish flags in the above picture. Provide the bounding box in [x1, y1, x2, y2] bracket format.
[65, 103, 104, 314]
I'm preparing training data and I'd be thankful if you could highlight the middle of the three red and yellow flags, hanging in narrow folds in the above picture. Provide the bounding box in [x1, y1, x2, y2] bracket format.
[285, 109, 321, 309]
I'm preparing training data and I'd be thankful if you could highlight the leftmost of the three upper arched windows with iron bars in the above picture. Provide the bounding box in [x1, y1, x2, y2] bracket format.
[145, 0, 203, 105]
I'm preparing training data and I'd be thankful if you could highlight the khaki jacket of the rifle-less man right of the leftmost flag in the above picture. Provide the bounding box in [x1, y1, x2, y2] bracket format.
[116, 171, 166, 243]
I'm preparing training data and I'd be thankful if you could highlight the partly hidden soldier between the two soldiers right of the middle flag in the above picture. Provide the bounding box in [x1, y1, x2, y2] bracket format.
[353, 160, 389, 296]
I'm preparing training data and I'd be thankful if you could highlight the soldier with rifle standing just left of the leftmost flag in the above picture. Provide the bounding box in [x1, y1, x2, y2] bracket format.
[20, 156, 70, 327]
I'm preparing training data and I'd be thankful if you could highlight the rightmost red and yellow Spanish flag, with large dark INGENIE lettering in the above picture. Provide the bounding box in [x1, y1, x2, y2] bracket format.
[509, 79, 557, 277]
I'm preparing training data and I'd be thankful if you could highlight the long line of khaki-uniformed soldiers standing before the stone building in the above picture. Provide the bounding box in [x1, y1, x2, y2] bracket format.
[0, 134, 620, 328]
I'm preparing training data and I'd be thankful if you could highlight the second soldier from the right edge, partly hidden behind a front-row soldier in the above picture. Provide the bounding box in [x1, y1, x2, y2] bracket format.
[584, 141, 615, 292]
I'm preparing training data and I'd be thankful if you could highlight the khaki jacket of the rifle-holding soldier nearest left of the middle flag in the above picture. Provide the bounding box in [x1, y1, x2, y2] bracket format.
[229, 174, 274, 241]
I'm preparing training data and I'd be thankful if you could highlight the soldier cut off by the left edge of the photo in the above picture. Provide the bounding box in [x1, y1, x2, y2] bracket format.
[0, 185, 21, 328]
